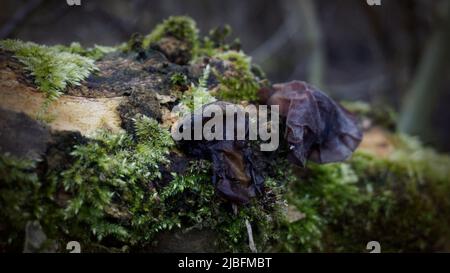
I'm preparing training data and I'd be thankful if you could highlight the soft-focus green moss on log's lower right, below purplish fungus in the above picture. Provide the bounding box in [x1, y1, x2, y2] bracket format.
[281, 133, 450, 252]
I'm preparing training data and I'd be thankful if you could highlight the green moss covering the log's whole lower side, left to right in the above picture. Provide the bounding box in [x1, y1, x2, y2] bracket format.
[0, 114, 450, 252]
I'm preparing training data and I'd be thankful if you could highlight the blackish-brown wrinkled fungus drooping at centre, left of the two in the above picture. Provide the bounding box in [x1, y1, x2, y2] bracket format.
[180, 101, 264, 204]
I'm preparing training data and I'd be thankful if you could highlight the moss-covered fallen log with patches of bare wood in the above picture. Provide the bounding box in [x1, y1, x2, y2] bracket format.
[0, 17, 450, 252]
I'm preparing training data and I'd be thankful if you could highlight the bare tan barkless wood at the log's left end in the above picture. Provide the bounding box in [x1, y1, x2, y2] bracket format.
[0, 50, 124, 135]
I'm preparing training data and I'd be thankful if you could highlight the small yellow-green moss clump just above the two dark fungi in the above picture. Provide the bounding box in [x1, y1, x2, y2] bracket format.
[213, 50, 260, 102]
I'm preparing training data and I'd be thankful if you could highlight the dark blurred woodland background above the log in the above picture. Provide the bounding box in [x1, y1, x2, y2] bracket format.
[0, 0, 450, 152]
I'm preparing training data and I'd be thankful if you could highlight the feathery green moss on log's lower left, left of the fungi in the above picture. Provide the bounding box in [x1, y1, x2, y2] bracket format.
[0, 117, 173, 251]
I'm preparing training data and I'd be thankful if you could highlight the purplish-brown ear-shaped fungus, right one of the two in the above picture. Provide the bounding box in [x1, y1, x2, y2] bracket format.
[261, 81, 362, 165]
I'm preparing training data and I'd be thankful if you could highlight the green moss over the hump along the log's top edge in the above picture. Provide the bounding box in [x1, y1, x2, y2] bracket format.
[135, 16, 264, 102]
